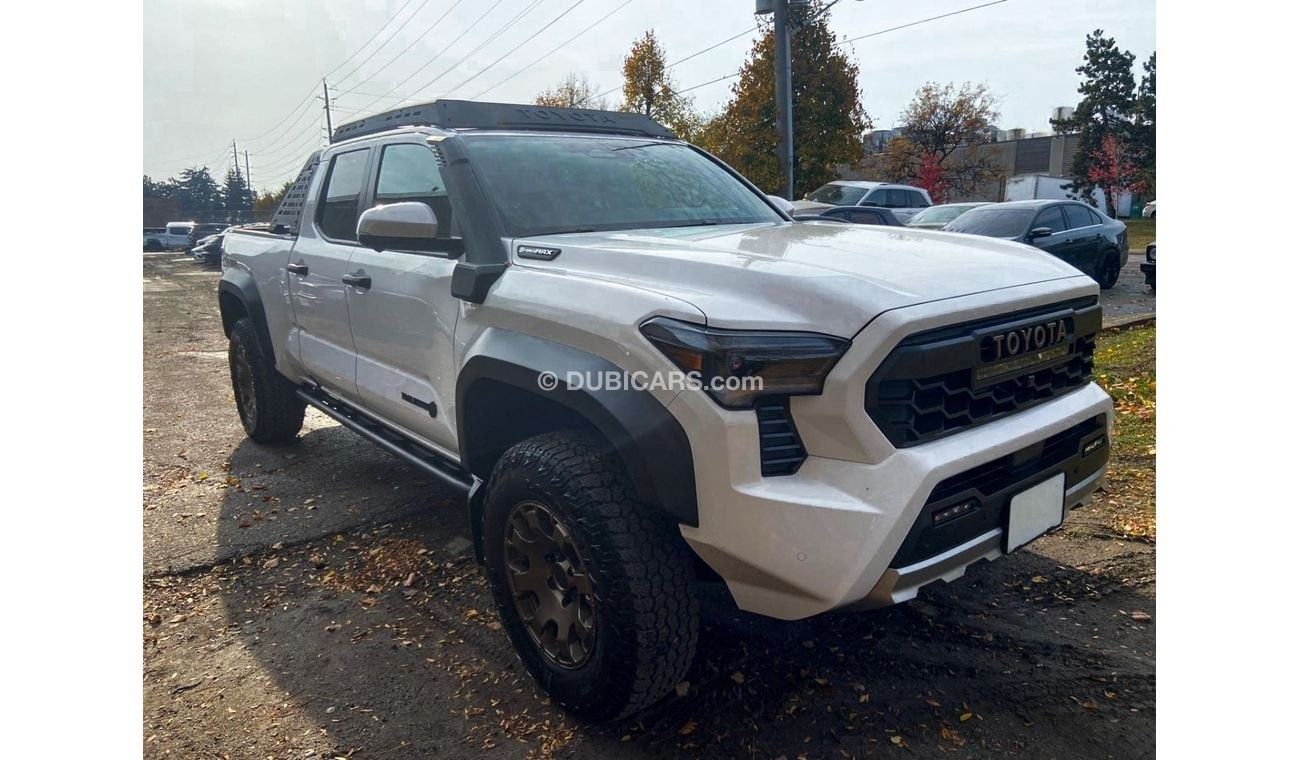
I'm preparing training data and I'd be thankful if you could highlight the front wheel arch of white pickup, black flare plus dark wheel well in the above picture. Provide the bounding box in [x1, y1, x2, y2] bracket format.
[456, 331, 699, 550]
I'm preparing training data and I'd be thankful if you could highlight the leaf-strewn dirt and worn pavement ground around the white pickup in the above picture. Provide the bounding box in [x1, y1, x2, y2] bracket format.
[142, 255, 1156, 759]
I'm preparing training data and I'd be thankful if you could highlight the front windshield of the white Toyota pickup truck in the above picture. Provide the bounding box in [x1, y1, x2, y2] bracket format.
[464, 135, 784, 236]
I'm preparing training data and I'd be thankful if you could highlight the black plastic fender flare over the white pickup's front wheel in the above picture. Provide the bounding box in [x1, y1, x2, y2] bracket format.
[456, 331, 699, 526]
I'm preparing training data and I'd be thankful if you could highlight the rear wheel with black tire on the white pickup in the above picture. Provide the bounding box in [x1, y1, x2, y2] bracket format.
[228, 317, 307, 443]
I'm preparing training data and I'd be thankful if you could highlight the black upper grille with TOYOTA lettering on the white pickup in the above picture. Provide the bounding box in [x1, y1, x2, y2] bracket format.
[866, 298, 1101, 447]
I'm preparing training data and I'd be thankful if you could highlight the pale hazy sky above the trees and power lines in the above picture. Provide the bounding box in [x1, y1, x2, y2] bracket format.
[144, 0, 1156, 191]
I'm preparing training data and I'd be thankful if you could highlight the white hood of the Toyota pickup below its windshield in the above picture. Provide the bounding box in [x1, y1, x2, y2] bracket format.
[512, 223, 1082, 338]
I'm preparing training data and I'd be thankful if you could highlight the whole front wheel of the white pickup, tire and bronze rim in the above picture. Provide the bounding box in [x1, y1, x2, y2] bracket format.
[484, 431, 699, 721]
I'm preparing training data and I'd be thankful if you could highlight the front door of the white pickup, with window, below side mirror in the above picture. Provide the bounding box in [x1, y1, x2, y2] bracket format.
[347, 138, 464, 457]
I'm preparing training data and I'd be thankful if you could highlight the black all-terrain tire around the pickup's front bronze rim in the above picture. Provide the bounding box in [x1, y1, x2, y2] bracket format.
[484, 431, 699, 721]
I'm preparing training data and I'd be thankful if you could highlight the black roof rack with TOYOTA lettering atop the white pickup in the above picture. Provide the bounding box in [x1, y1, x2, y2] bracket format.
[330, 100, 676, 143]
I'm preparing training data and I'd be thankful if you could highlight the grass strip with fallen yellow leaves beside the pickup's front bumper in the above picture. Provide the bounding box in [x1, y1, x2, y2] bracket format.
[1096, 323, 1156, 542]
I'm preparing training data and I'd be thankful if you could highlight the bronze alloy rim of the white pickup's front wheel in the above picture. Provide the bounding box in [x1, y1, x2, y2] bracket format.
[504, 500, 597, 669]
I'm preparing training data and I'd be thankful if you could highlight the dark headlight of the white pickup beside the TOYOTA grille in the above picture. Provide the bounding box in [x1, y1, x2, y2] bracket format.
[641, 317, 849, 409]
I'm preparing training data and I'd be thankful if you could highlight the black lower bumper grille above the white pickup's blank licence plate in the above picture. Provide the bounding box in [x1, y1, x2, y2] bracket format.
[889, 414, 1110, 568]
